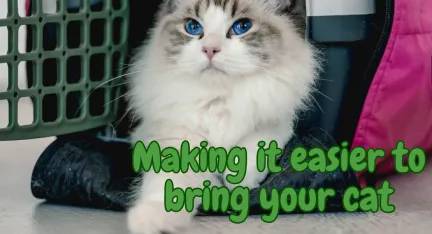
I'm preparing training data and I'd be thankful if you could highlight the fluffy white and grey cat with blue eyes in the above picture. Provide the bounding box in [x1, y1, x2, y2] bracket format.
[127, 0, 319, 234]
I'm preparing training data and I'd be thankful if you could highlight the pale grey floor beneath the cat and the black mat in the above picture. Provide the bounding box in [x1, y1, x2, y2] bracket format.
[0, 99, 432, 234]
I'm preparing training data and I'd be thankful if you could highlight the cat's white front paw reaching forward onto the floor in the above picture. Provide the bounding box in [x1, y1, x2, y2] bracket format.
[127, 201, 192, 234]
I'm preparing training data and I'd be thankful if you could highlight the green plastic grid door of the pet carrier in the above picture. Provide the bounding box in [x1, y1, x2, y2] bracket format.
[0, 0, 129, 141]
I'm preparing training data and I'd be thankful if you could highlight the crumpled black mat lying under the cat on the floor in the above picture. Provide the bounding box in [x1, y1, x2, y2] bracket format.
[31, 129, 358, 214]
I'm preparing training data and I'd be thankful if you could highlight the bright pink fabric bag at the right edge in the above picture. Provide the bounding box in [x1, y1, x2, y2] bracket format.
[353, 0, 432, 186]
